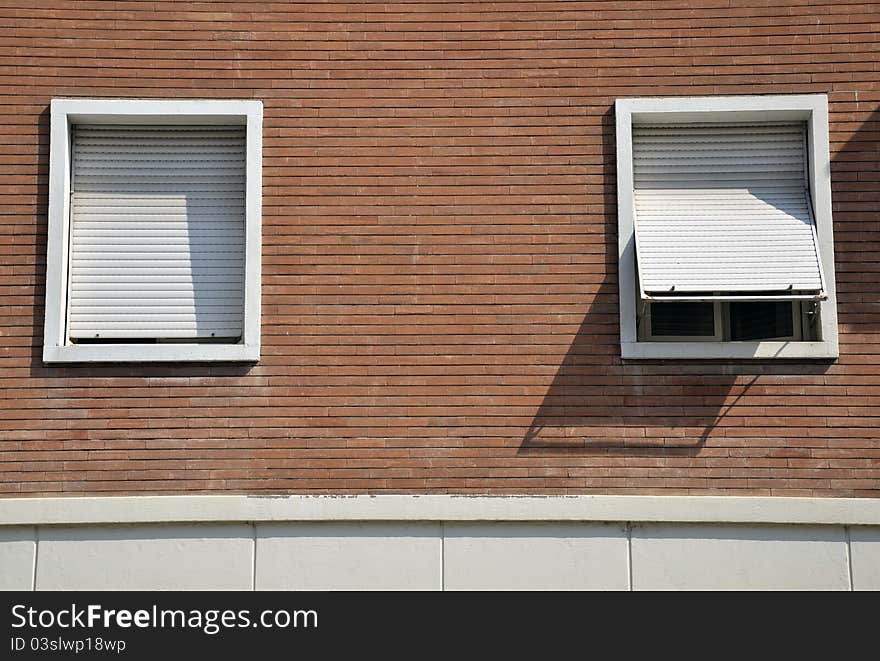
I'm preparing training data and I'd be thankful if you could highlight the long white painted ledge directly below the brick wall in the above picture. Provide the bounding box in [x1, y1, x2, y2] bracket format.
[0, 495, 880, 526]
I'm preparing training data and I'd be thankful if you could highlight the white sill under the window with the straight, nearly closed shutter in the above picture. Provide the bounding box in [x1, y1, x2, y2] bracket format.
[43, 344, 260, 363]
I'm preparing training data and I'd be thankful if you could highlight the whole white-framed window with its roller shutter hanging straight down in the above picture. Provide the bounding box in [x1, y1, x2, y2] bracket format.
[43, 99, 262, 362]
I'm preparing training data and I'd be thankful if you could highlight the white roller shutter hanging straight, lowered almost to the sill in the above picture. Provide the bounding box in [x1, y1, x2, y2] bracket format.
[68, 125, 245, 339]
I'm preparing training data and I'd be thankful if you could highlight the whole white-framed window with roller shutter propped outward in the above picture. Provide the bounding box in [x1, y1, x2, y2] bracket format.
[616, 95, 838, 358]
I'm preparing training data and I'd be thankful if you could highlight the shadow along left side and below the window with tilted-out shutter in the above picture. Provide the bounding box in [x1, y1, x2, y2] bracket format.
[518, 106, 832, 457]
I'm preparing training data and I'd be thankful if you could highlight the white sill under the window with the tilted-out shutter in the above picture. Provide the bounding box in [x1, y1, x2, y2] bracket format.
[620, 342, 838, 360]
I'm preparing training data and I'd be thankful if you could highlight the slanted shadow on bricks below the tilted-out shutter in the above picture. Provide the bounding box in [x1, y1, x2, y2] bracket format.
[520, 276, 784, 455]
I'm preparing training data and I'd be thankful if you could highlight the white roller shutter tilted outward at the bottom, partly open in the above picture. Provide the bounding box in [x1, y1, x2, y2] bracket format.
[633, 122, 824, 300]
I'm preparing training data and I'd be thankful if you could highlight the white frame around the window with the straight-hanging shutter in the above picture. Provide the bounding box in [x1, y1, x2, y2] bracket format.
[43, 99, 263, 363]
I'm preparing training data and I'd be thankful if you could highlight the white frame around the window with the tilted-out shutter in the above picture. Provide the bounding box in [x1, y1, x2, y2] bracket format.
[615, 94, 839, 359]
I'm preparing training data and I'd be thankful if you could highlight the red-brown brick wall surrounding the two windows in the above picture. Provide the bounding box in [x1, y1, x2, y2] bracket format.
[0, 0, 880, 496]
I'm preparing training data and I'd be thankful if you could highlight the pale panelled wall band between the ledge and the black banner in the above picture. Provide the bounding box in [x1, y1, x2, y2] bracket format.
[0, 522, 880, 590]
